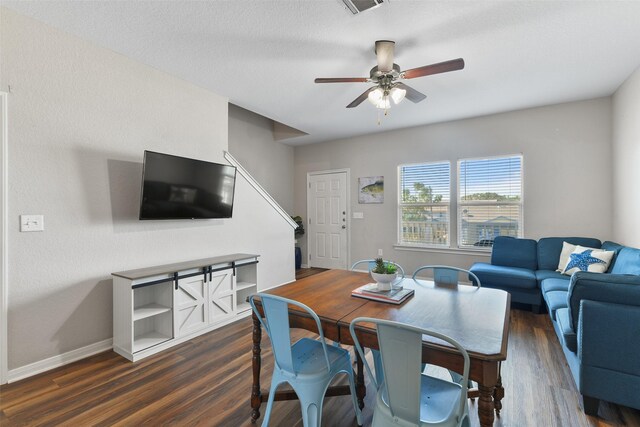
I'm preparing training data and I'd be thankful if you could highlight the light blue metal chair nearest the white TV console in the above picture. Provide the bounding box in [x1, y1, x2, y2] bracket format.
[249, 294, 362, 427]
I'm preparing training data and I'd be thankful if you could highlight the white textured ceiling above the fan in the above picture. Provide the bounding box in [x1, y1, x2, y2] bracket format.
[2, 0, 640, 145]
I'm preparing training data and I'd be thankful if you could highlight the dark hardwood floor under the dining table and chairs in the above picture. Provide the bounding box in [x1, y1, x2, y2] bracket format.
[0, 272, 640, 427]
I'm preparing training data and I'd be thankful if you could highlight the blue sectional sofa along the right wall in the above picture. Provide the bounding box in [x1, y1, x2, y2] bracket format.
[470, 237, 640, 415]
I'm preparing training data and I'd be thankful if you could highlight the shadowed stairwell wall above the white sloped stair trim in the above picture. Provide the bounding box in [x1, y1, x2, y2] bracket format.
[229, 104, 294, 215]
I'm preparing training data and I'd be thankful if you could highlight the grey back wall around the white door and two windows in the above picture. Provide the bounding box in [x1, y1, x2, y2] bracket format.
[295, 98, 612, 271]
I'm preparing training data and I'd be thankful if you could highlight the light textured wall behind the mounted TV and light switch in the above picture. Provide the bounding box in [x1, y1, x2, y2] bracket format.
[0, 9, 294, 369]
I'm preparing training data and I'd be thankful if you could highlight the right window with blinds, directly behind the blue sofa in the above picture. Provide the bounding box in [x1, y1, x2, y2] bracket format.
[458, 155, 523, 247]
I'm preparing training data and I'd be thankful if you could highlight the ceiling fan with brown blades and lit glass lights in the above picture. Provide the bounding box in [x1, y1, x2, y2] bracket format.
[315, 40, 464, 110]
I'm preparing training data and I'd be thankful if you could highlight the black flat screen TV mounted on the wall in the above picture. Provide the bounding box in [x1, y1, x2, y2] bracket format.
[140, 151, 236, 220]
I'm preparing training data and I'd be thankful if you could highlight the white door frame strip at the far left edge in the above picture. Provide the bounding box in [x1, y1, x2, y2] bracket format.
[0, 91, 9, 384]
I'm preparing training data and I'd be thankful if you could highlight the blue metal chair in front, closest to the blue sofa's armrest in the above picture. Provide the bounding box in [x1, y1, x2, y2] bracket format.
[349, 317, 470, 427]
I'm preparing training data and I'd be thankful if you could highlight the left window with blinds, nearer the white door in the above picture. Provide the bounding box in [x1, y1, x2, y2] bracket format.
[398, 162, 451, 247]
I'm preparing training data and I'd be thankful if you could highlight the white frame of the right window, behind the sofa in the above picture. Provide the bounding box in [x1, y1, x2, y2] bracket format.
[456, 153, 524, 252]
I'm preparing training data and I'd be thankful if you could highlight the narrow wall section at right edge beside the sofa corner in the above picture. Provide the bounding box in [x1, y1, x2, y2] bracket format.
[612, 68, 640, 248]
